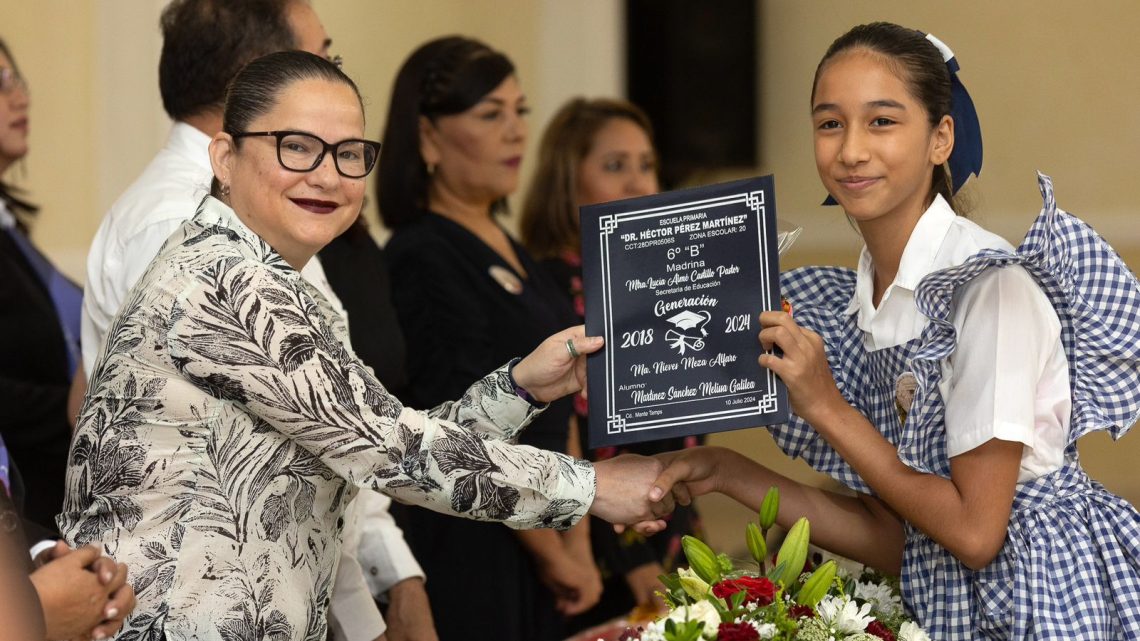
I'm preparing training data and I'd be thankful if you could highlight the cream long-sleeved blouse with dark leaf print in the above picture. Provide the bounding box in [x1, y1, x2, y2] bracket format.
[59, 197, 595, 641]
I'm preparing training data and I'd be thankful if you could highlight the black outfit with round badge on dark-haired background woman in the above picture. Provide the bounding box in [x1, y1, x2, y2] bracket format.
[385, 213, 575, 641]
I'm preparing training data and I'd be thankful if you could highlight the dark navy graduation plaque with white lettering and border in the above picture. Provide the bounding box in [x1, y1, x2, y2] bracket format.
[580, 177, 788, 447]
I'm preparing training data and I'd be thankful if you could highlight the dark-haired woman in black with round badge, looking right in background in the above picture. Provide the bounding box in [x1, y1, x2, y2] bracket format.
[378, 36, 601, 641]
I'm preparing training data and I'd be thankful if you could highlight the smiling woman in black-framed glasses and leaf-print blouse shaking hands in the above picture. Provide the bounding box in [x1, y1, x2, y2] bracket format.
[59, 51, 668, 641]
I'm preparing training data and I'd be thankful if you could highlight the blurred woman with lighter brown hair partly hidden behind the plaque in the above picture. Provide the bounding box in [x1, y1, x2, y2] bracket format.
[519, 98, 699, 628]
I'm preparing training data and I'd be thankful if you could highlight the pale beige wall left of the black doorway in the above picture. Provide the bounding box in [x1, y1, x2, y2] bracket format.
[0, 0, 624, 274]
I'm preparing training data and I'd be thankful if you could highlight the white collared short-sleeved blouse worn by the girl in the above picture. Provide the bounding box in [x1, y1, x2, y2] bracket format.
[847, 196, 1072, 484]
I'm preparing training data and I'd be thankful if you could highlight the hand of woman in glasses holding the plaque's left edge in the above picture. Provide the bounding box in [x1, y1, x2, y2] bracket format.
[512, 325, 604, 403]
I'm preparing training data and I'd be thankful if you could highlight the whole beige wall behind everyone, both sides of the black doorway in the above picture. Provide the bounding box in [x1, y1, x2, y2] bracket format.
[0, 0, 1140, 549]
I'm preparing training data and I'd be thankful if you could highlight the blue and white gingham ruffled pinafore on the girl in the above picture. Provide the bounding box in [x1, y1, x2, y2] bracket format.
[772, 175, 1140, 640]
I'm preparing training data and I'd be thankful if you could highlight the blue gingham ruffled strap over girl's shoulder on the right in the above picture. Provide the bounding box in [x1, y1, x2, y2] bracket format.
[899, 173, 1140, 453]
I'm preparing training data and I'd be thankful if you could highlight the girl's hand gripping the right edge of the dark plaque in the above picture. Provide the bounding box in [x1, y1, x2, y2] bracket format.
[759, 311, 847, 425]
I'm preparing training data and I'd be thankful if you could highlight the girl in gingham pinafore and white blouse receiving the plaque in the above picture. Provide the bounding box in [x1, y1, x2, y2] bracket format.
[654, 23, 1140, 640]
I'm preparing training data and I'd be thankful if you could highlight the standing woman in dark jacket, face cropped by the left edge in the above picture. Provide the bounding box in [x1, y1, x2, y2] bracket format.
[0, 33, 83, 534]
